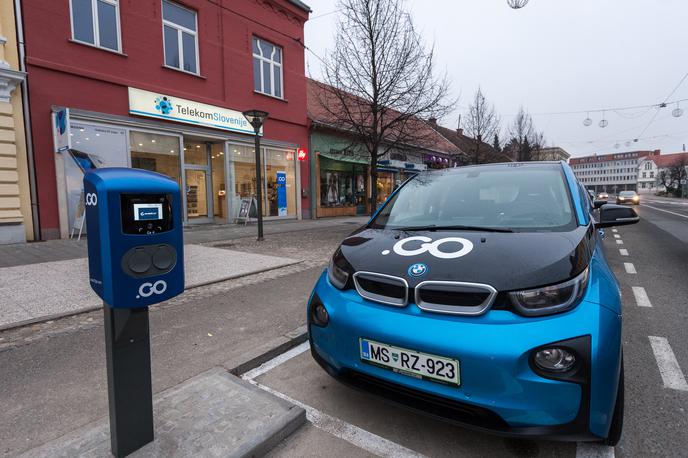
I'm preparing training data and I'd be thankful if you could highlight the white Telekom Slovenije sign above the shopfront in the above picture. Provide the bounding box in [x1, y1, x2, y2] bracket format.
[129, 87, 262, 135]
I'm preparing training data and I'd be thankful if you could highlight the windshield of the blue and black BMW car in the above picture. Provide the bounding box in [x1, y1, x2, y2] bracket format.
[370, 164, 575, 231]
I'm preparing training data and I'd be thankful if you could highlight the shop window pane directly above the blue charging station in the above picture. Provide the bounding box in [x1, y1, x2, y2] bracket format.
[129, 130, 181, 184]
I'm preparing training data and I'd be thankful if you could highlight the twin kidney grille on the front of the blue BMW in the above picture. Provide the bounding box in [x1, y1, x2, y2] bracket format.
[353, 272, 497, 315]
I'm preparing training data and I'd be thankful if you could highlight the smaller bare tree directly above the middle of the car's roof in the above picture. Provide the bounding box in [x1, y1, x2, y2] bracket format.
[464, 87, 500, 164]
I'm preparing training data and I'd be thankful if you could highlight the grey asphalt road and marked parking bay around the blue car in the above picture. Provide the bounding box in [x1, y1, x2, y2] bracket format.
[248, 198, 688, 458]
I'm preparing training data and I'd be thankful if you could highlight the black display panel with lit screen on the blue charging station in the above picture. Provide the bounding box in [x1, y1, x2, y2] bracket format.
[121, 194, 172, 235]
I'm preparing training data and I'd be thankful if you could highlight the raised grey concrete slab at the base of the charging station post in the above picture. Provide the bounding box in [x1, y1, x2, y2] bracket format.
[20, 368, 306, 458]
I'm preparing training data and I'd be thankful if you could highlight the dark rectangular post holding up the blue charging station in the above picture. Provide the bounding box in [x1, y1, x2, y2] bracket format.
[103, 303, 154, 458]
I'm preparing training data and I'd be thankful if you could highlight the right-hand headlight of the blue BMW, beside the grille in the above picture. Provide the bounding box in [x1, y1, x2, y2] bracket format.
[509, 267, 590, 316]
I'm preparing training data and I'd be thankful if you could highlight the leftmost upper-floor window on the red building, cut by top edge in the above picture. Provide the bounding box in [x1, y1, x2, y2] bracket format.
[69, 0, 121, 52]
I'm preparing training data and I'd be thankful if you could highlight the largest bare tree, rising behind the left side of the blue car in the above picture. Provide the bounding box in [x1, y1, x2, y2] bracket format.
[315, 0, 454, 211]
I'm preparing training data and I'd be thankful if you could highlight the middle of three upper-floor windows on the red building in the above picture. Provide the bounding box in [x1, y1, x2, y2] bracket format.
[162, 0, 199, 74]
